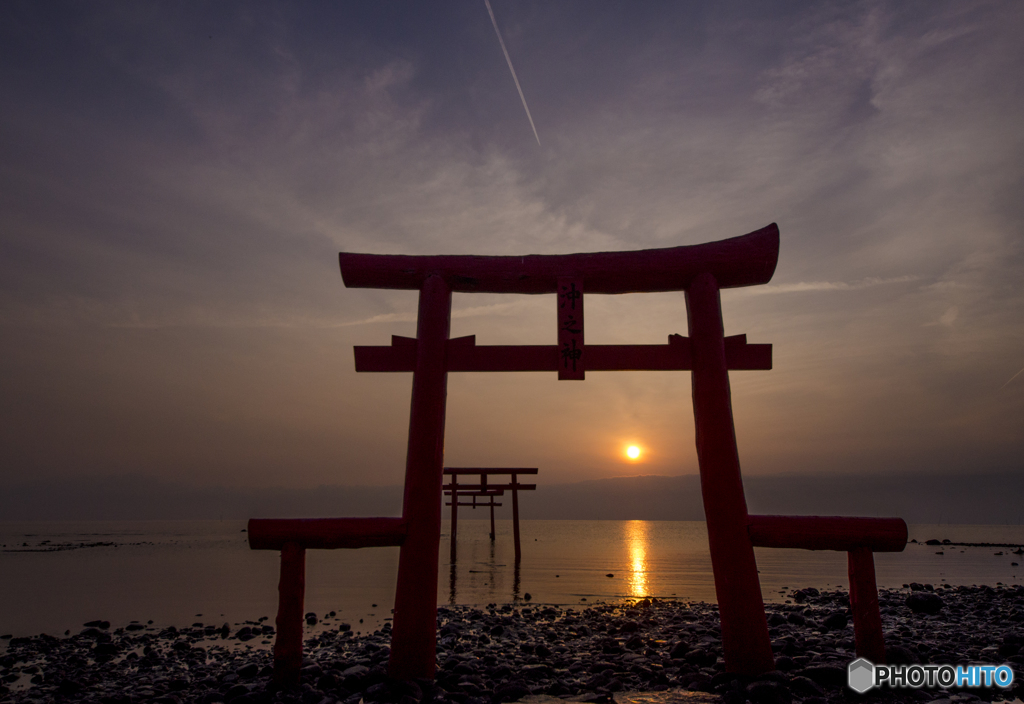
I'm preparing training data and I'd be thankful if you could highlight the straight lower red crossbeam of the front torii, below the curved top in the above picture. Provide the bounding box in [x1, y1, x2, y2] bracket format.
[354, 335, 771, 371]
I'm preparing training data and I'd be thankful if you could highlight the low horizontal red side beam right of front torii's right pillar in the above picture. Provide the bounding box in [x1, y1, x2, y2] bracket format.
[746, 516, 907, 553]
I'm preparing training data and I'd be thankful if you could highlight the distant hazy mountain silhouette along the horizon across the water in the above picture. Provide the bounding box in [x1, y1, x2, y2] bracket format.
[0, 472, 1024, 525]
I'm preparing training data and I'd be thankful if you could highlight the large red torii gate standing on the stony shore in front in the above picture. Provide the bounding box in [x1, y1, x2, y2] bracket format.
[250, 224, 907, 679]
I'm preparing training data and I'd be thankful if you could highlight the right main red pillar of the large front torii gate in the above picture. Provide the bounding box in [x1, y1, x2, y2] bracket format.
[686, 273, 775, 674]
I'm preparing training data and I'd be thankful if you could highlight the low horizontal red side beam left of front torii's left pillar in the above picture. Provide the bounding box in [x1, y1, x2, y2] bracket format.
[248, 518, 408, 551]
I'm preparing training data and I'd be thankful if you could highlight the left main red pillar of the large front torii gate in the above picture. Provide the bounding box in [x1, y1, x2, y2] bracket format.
[388, 275, 452, 679]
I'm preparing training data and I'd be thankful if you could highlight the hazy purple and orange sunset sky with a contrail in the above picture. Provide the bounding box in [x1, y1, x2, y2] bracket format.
[0, 0, 1024, 505]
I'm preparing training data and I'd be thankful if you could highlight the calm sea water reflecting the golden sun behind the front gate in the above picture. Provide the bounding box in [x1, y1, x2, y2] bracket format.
[0, 519, 1024, 649]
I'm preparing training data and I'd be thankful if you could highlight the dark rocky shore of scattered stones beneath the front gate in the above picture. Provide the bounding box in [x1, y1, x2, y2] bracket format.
[0, 584, 1024, 704]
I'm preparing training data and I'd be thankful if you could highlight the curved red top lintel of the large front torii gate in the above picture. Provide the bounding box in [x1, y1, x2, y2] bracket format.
[339, 223, 778, 294]
